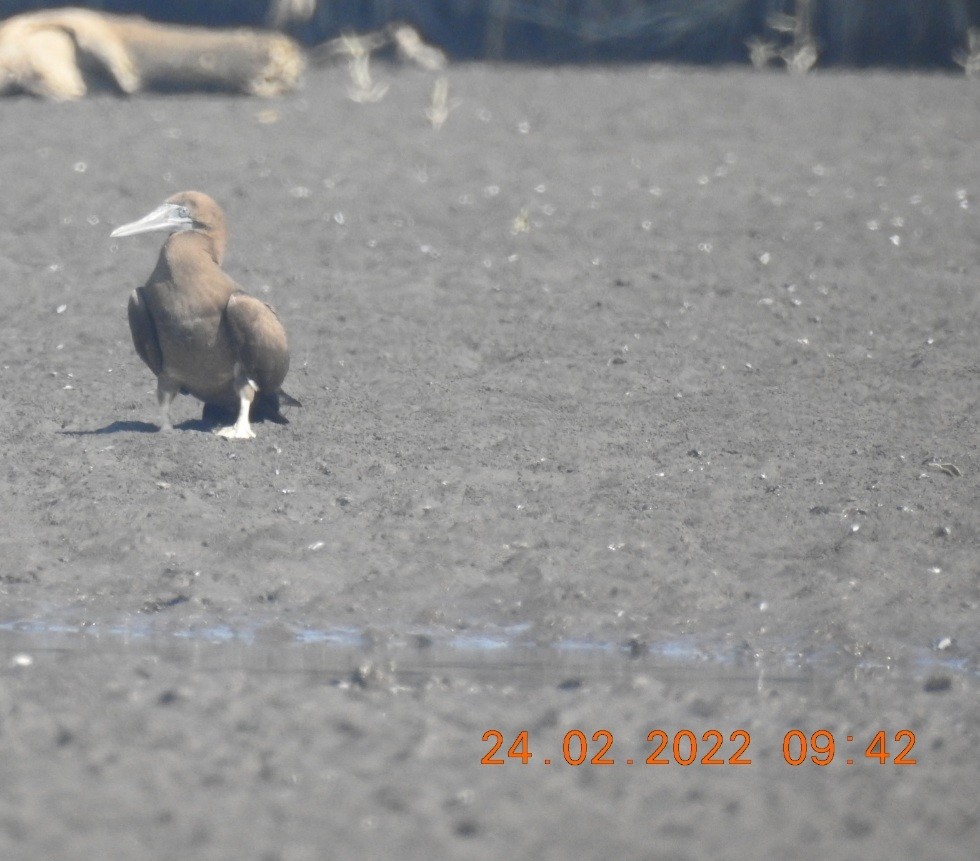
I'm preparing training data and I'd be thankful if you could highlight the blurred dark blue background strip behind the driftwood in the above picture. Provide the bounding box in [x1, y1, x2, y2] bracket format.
[0, 0, 980, 69]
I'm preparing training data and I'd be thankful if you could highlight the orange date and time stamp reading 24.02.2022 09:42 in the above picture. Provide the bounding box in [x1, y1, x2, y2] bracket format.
[480, 729, 917, 767]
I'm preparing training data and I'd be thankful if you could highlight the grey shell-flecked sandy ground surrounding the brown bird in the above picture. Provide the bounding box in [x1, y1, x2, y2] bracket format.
[0, 65, 980, 859]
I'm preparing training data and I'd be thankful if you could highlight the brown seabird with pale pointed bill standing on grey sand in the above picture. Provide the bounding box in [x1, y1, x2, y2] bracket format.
[110, 191, 301, 440]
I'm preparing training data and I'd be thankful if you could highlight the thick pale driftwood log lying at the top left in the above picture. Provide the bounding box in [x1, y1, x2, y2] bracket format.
[0, 8, 304, 101]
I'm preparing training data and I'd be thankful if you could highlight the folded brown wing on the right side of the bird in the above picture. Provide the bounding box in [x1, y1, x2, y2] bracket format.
[225, 292, 289, 392]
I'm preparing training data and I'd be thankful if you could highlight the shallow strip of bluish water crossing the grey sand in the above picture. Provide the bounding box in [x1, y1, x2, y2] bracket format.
[0, 617, 980, 687]
